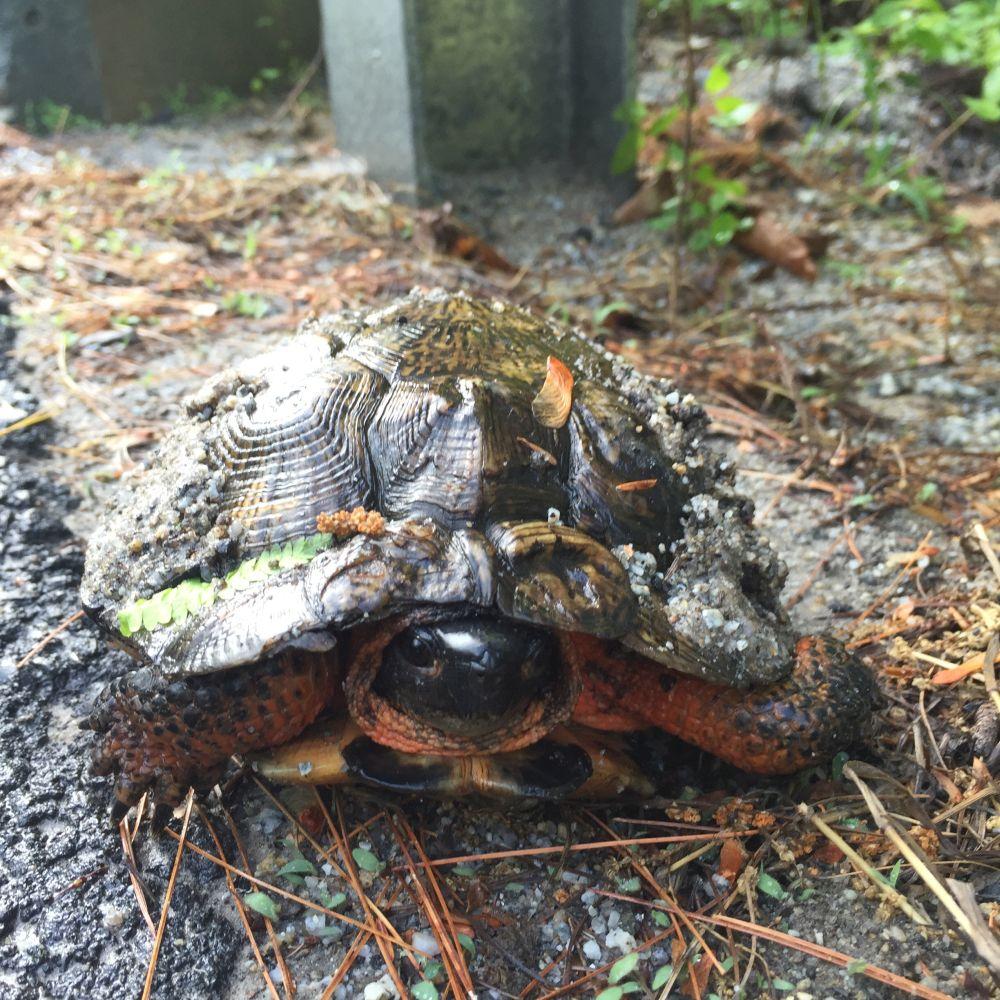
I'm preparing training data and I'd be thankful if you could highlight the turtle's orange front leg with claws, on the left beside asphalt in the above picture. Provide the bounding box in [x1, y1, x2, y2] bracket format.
[84, 651, 337, 822]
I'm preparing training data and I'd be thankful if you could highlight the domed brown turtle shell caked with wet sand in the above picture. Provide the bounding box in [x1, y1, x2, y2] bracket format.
[82, 291, 794, 686]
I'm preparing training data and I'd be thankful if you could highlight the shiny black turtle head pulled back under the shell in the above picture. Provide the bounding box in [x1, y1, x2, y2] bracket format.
[372, 615, 559, 738]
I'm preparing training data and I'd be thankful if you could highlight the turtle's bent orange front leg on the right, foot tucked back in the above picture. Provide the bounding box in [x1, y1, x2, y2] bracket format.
[563, 635, 875, 774]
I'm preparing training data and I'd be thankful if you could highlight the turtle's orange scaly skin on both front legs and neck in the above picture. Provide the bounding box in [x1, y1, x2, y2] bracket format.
[90, 620, 873, 815]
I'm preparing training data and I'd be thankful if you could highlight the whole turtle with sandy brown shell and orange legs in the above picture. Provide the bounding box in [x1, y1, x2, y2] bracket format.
[81, 289, 875, 818]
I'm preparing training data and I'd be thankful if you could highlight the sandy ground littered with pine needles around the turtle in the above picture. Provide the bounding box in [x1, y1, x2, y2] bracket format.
[0, 29, 1000, 1000]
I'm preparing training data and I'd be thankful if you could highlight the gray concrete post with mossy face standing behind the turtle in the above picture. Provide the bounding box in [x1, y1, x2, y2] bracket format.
[320, 0, 636, 196]
